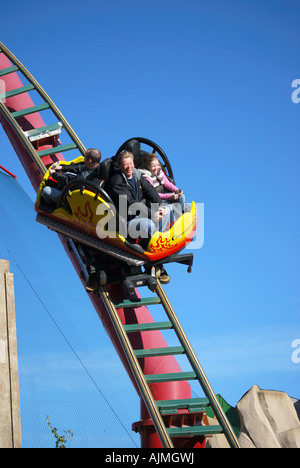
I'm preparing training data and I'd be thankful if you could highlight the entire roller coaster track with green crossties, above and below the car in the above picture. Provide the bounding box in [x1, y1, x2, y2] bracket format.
[0, 43, 239, 448]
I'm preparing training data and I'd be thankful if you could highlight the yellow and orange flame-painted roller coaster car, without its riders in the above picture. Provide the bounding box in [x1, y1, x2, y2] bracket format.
[35, 138, 197, 263]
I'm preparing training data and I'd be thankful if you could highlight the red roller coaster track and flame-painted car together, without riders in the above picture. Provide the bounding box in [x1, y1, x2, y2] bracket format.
[0, 43, 239, 448]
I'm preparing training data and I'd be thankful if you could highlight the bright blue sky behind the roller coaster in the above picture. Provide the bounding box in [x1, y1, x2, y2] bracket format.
[0, 0, 300, 446]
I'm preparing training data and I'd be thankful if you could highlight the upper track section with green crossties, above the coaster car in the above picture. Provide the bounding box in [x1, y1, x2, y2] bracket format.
[0, 42, 86, 175]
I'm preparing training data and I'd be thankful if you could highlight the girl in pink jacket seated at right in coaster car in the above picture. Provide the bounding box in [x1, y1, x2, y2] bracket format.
[139, 153, 185, 213]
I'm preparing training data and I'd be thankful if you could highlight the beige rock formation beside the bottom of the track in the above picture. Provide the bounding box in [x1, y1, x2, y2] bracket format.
[208, 385, 300, 448]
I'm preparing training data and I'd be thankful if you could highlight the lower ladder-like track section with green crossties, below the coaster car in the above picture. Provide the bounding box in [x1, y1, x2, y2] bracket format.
[99, 281, 240, 448]
